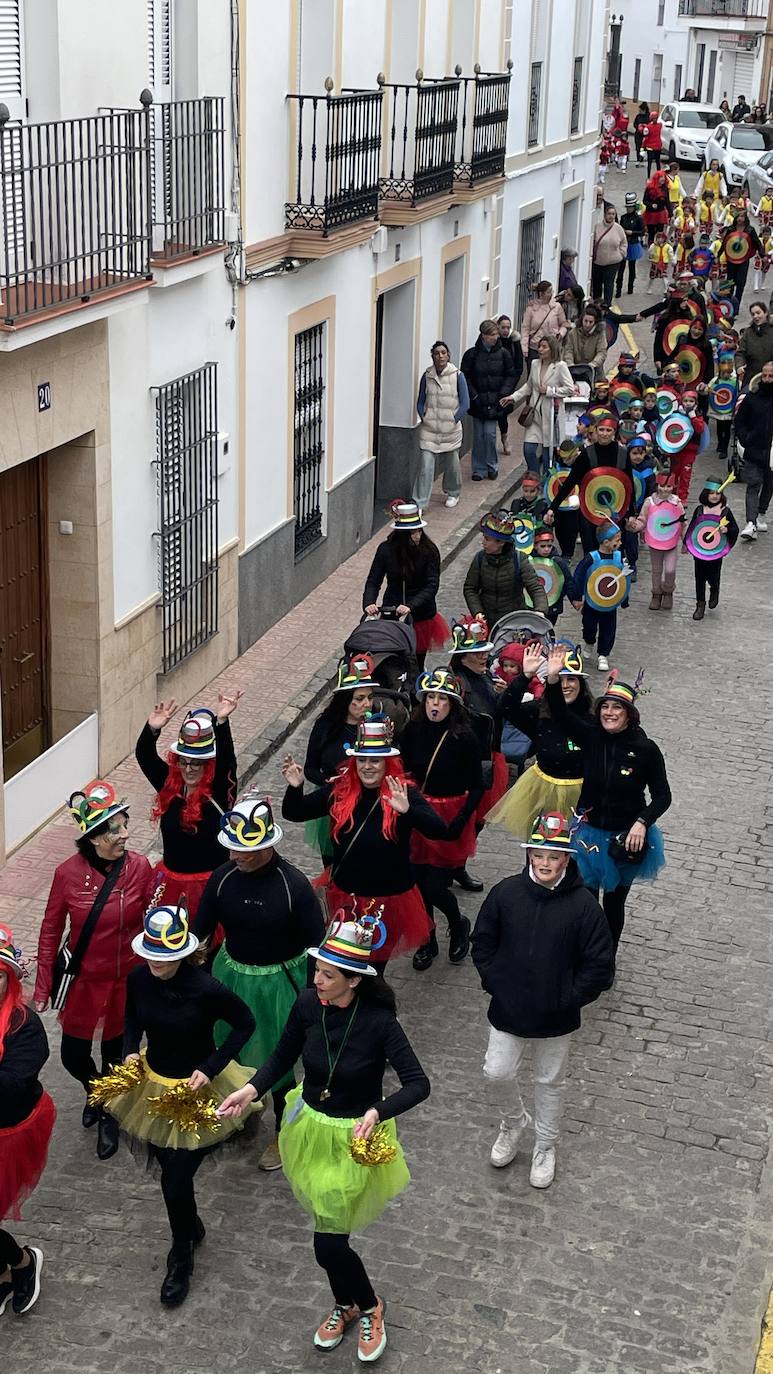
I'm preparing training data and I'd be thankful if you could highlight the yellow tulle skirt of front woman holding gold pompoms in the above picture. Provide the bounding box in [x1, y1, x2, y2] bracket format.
[106, 1050, 264, 1150]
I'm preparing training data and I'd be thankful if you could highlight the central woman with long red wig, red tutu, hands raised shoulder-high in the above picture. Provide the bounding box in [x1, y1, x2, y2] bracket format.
[281, 712, 464, 969]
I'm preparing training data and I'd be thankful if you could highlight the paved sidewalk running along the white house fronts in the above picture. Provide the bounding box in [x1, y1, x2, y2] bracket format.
[0, 439, 523, 955]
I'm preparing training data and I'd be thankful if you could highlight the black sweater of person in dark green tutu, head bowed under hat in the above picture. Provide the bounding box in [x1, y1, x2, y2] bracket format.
[194, 853, 324, 966]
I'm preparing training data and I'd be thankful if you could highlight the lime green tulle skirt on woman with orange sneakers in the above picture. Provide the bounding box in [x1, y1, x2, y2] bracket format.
[279, 1083, 411, 1235]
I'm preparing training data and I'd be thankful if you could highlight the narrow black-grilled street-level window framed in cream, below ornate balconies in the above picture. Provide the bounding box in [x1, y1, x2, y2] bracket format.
[292, 322, 327, 559]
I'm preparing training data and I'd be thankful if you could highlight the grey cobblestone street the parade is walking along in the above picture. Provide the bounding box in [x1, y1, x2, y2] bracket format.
[0, 160, 773, 1374]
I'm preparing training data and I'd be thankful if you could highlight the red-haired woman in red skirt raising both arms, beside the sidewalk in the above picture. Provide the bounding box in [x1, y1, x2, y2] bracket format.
[135, 691, 242, 923]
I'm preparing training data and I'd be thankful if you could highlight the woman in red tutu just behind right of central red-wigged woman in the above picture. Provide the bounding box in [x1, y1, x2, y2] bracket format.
[400, 668, 483, 973]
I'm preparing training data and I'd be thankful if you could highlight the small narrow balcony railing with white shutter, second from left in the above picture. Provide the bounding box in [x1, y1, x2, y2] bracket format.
[151, 96, 225, 262]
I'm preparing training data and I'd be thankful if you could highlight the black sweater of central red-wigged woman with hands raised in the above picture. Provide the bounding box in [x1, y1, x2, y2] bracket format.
[281, 783, 458, 897]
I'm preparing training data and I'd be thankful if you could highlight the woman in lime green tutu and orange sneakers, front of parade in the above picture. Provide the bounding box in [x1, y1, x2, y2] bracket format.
[218, 912, 430, 1363]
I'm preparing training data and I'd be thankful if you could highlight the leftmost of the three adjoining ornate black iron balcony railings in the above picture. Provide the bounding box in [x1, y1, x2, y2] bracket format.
[284, 77, 383, 235]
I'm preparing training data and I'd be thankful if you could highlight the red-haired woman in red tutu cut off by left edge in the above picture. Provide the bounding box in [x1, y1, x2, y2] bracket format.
[0, 927, 56, 1316]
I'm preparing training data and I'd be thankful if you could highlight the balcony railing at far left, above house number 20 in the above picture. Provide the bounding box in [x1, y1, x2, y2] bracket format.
[0, 102, 151, 324]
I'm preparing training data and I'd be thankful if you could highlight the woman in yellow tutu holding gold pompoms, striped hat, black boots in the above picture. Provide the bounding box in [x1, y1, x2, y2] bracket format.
[96, 905, 258, 1307]
